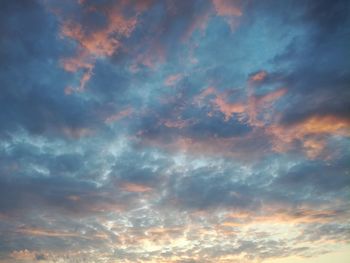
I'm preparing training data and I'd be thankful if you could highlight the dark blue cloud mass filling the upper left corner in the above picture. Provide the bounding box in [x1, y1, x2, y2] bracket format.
[0, 1, 100, 137]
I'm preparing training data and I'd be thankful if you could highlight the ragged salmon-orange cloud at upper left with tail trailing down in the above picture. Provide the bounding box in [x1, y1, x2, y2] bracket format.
[56, 2, 137, 95]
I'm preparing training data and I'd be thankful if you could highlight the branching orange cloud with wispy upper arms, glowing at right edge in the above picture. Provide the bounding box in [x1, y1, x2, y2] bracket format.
[182, 84, 350, 159]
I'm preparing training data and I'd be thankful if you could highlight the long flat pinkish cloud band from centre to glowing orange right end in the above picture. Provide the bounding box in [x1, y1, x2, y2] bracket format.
[138, 116, 350, 161]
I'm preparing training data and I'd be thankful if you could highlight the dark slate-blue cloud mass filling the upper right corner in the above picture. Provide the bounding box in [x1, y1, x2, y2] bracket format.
[268, 1, 350, 126]
